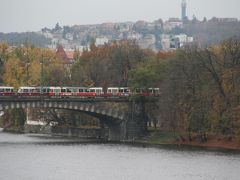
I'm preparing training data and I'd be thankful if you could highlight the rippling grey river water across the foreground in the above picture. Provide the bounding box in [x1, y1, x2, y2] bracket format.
[0, 132, 240, 180]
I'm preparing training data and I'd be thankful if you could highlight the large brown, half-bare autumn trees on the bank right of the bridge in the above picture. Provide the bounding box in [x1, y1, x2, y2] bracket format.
[160, 38, 240, 140]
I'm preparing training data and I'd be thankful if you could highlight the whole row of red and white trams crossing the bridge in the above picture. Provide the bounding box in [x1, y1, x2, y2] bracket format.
[0, 86, 160, 98]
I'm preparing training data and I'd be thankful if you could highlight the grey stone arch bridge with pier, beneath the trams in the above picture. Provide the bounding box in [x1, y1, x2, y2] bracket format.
[0, 97, 150, 140]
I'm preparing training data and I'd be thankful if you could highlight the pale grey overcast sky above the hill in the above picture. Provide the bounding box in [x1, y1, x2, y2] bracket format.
[0, 0, 240, 32]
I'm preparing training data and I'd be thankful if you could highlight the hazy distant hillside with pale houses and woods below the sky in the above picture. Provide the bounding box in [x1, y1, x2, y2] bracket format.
[0, 18, 240, 50]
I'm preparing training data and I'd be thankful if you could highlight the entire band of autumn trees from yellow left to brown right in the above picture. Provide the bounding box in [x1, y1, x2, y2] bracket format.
[0, 38, 240, 140]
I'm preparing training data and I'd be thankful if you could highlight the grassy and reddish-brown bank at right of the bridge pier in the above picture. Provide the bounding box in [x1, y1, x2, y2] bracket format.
[139, 131, 240, 151]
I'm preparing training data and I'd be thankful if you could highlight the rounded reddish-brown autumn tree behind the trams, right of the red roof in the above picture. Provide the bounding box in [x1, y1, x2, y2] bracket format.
[72, 41, 147, 87]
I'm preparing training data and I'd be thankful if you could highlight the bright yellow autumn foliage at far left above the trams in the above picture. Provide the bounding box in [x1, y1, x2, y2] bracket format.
[0, 44, 56, 87]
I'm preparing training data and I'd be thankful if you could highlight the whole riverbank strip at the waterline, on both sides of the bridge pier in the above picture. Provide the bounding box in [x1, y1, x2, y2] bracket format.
[2, 127, 240, 151]
